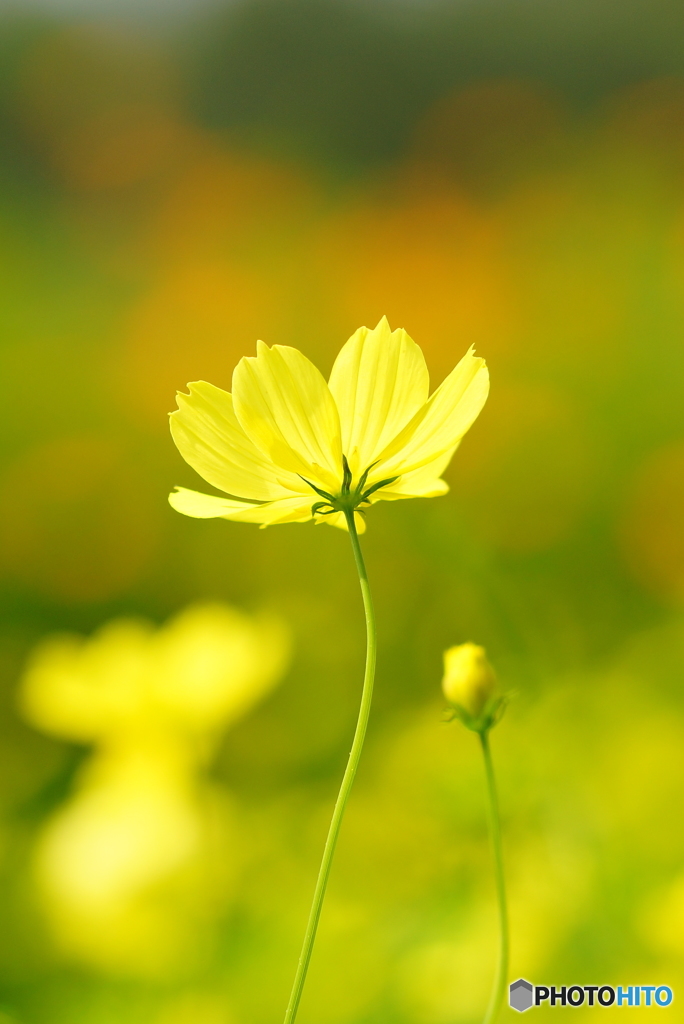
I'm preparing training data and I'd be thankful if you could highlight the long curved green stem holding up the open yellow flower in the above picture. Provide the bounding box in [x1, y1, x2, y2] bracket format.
[285, 510, 377, 1024]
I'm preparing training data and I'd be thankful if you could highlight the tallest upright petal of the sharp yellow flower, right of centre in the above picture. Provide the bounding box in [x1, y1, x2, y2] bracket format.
[330, 316, 429, 475]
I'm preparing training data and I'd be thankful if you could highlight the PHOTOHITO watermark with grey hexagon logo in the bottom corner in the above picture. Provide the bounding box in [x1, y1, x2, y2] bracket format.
[508, 978, 675, 1014]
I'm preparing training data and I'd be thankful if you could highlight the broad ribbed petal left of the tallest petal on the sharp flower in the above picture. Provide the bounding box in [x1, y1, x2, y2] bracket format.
[232, 342, 342, 489]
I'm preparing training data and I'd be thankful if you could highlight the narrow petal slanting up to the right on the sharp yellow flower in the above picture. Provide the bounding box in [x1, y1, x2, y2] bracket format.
[369, 349, 489, 482]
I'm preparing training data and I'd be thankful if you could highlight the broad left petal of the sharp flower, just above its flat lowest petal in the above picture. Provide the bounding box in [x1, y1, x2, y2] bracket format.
[170, 381, 304, 501]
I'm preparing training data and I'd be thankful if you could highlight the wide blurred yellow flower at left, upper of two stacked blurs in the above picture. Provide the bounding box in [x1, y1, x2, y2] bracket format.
[22, 604, 288, 743]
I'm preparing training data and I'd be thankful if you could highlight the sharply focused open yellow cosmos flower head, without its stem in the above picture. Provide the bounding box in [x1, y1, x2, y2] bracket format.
[169, 317, 488, 530]
